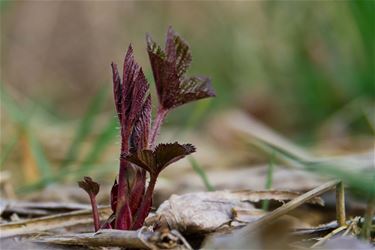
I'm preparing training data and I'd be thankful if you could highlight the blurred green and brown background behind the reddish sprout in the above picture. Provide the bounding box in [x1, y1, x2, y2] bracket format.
[0, 1, 375, 198]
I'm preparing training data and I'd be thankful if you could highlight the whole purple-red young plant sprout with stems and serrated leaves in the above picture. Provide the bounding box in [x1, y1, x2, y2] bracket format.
[79, 27, 215, 231]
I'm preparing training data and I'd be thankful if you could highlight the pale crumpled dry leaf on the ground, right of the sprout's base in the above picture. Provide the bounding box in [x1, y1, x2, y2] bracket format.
[146, 190, 323, 233]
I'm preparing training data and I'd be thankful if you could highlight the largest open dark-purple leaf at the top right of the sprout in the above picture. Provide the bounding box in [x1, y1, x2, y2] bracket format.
[147, 27, 215, 109]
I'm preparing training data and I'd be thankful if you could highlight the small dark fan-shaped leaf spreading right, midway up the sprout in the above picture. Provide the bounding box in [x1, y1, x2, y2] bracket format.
[125, 142, 195, 176]
